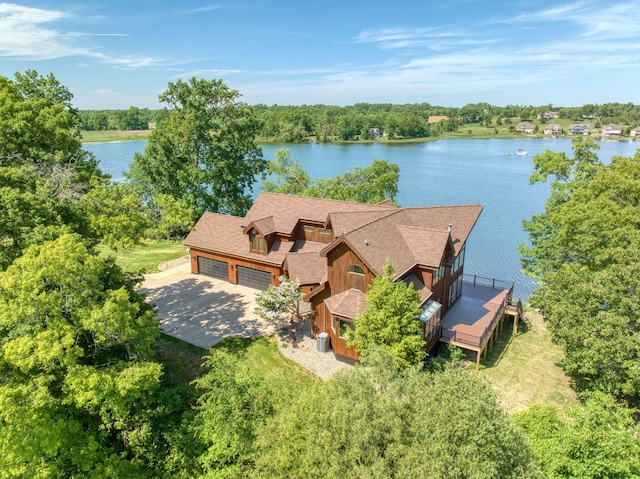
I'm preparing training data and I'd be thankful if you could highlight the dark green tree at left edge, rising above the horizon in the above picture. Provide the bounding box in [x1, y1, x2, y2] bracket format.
[0, 70, 104, 270]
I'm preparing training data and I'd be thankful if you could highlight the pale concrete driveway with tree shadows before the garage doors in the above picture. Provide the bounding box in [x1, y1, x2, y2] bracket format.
[140, 263, 277, 348]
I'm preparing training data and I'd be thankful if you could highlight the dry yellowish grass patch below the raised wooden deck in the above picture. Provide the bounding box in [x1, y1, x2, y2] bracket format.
[473, 311, 578, 413]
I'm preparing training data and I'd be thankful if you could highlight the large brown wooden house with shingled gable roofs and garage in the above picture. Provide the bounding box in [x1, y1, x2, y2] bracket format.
[184, 192, 506, 361]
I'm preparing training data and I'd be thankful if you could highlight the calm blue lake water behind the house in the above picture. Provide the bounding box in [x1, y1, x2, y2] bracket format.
[84, 138, 640, 298]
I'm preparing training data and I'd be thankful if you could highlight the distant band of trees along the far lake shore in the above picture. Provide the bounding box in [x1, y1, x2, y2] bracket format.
[79, 99, 640, 143]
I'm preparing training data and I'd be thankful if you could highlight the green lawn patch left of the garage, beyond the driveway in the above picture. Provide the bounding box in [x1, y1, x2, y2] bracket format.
[98, 240, 185, 273]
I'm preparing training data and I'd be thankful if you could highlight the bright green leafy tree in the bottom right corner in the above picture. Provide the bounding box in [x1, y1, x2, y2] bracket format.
[514, 393, 640, 479]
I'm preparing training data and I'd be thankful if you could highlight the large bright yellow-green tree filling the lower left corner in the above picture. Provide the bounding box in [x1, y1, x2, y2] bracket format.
[0, 234, 162, 477]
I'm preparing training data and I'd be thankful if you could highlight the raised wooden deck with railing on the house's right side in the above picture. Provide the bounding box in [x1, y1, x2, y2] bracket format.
[440, 281, 521, 367]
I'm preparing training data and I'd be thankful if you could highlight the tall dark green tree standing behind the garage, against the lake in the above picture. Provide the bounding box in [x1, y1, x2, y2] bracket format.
[128, 78, 266, 216]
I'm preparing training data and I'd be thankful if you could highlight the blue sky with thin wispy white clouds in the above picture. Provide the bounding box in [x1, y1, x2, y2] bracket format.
[0, 0, 640, 109]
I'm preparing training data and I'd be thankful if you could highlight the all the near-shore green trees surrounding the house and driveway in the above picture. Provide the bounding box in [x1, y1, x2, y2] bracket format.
[0, 71, 640, 479]
